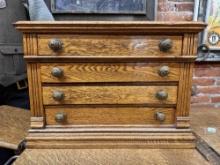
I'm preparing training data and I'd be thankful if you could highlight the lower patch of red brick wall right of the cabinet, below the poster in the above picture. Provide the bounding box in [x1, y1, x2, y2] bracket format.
[192, 63, 220, 107]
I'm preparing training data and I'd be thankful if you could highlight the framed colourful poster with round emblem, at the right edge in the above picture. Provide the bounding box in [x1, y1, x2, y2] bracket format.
[194, 0, 220, 61]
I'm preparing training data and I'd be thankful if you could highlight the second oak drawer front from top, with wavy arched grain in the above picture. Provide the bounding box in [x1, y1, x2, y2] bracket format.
[40, 63, 180, 83]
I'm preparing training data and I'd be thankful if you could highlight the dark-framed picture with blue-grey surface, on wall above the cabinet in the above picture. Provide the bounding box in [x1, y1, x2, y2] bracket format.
[50, 0, 157, 20]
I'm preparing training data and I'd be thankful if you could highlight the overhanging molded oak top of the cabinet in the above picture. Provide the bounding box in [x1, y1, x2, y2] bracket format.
[14, 21, 206, 33]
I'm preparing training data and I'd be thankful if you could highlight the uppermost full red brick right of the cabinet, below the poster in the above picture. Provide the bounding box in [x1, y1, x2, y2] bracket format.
[195, 67, 220, 77]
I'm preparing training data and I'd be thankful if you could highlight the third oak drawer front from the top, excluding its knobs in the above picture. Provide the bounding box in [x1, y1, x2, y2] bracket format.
[43, 86, 177, 105]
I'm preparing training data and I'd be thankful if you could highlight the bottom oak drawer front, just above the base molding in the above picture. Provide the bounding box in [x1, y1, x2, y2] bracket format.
[46, 107, 175, 125]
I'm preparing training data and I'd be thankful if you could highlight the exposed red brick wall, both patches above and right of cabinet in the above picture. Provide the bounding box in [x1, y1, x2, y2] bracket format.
[157, 0, 220, 107]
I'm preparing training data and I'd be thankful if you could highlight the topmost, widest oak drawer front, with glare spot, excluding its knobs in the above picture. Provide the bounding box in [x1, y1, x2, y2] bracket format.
[38, 35, 182, 56]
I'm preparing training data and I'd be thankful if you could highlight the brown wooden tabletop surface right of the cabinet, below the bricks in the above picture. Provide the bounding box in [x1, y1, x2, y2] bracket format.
[191, 107, 220, 155]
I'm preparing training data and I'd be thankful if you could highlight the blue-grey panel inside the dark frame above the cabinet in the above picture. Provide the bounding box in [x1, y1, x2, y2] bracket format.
[51, 0, 147, 14]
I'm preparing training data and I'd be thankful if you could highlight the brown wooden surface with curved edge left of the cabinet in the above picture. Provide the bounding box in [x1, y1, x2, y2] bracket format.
[0, 106, 30, 150]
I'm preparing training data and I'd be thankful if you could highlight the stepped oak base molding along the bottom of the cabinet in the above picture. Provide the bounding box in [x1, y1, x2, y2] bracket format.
[27, 131, 195, 149]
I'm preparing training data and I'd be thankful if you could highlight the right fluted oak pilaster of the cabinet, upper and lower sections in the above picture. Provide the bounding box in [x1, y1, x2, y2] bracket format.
[176, 33, 198, 122]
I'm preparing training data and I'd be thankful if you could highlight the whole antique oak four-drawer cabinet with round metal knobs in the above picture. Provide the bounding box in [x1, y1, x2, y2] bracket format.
[15, 21, 206, 149]
